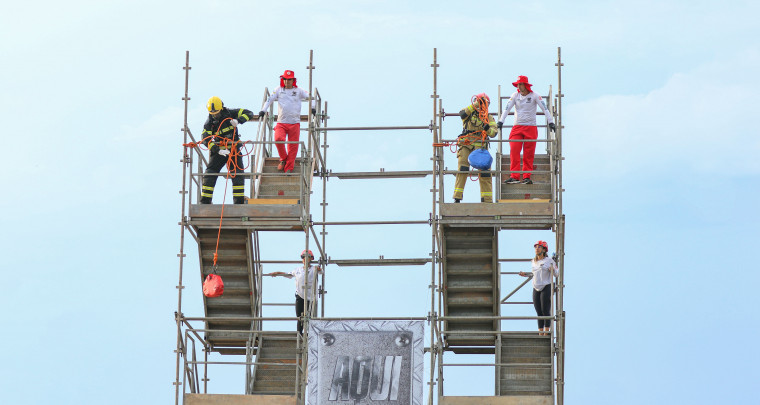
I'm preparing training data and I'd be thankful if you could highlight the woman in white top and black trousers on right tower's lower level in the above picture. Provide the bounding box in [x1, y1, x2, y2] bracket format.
[520, 240, 557, 336]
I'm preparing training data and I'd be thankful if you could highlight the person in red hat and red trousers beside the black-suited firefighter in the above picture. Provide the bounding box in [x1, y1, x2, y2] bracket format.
[259, 70, 317, 173]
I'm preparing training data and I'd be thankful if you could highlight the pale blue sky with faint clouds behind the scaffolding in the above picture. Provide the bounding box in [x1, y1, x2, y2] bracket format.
[0, 0, 760, 404]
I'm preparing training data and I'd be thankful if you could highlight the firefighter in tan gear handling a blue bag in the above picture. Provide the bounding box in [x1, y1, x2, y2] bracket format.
[454, 93, 498, 203]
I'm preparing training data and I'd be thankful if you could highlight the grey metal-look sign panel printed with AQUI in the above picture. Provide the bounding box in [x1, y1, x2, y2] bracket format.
[308, 320, 425, 405]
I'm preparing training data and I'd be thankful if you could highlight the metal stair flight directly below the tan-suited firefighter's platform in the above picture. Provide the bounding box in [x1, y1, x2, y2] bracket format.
[443, 227, 499, 353]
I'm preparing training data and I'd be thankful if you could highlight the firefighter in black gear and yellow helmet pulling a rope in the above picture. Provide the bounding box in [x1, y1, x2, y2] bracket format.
[201, 96, 253, 204]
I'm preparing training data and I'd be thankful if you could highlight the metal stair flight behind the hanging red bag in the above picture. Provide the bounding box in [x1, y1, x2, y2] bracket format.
[198, 228, 257, 354]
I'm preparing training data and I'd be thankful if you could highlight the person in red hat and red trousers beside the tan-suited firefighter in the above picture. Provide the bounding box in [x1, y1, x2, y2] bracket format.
[496, 76, 556, 184]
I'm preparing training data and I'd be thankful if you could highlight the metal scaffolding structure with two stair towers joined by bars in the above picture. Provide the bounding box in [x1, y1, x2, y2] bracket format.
[174, 48, 565, 405]
